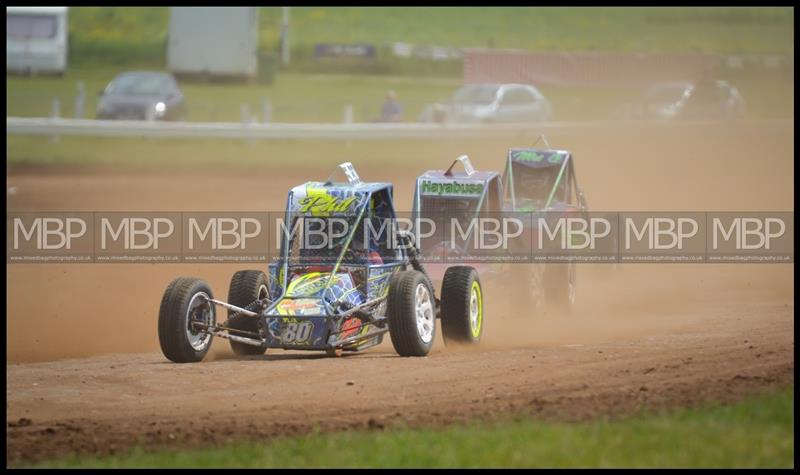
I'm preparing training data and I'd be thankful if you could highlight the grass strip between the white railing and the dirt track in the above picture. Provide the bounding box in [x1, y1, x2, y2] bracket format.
[6, 135, 524, 176]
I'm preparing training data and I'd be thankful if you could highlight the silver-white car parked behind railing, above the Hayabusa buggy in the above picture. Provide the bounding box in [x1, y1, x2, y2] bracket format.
[420, 84, 553, 123]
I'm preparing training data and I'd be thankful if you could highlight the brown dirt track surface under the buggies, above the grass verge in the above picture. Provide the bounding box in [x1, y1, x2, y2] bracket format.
[7, 276, 794, 464]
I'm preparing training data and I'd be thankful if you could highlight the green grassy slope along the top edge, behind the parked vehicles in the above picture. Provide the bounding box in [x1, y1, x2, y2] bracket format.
[70, 7, 794, 67]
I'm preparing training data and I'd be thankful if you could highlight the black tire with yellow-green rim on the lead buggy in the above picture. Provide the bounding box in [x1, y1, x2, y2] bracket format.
[441, 266, 484, 345]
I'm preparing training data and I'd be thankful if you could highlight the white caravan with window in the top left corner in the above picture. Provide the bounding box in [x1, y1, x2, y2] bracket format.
[6, 7, 67, 75]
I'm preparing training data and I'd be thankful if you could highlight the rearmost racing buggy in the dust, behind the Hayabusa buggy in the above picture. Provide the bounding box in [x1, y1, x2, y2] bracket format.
[503, 136, 588, 312]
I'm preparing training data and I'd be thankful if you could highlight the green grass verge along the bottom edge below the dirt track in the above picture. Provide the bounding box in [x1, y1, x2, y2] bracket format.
[29, 387, 794, 468]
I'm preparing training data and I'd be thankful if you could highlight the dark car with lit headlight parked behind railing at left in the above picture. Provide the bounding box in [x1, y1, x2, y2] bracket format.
[97, 72, 186, 121]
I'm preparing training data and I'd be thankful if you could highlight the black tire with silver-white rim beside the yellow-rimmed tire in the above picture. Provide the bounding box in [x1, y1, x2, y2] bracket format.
[386, 270, 436, 356]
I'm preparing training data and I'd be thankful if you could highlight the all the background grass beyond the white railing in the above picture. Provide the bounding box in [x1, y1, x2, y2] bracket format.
[6, 7, 794, 122]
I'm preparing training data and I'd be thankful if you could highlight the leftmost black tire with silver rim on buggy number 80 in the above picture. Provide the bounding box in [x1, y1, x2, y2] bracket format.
[158, 277, 216, 363]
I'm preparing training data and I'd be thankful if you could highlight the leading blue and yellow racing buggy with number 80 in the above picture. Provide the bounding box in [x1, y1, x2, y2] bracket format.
[158, 163, 484, 363]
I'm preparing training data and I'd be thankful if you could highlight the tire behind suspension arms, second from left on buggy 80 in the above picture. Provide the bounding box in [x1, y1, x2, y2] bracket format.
[227, 270, 269, 356]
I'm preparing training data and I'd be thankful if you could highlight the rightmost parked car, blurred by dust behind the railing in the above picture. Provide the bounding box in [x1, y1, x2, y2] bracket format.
[614, 80, 745, 120]
